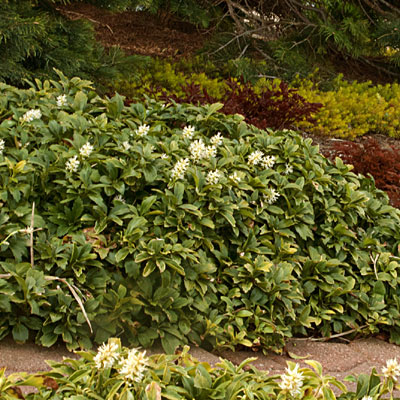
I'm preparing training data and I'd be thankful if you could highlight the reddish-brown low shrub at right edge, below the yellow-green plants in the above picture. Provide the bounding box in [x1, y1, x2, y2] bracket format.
[324, 137, 400, 208]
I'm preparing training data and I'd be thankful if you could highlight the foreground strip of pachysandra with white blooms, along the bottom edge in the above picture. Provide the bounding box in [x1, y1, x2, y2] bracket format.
[0, 338, 400, 400]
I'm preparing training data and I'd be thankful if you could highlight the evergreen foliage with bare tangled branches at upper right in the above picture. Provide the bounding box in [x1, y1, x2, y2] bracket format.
[203, 0, 400, 80]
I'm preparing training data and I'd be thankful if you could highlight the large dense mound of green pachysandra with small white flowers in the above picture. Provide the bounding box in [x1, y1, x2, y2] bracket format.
[0, 75, 400, 351]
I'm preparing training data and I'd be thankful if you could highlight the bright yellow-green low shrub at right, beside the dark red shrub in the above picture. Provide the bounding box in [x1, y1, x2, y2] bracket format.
[296, 76, 400, 138]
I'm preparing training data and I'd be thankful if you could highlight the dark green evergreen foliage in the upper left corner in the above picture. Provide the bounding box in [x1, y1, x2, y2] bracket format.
[0, 0, 139, 85]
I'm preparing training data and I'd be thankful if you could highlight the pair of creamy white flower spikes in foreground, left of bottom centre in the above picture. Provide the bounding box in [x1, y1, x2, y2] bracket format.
[93, 342, 148, 385]
